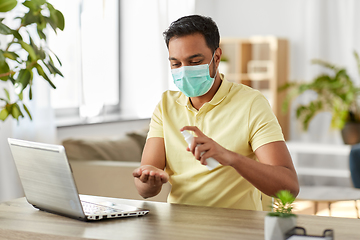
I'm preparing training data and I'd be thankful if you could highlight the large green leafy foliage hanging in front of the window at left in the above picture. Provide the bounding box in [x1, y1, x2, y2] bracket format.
[0, 0, 65, 121]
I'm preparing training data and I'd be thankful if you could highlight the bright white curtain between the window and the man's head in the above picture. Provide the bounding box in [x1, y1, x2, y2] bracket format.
[120, 0, 195, 117]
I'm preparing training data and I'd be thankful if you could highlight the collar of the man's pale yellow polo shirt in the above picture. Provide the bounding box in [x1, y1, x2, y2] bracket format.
[176, 74, 231, 107]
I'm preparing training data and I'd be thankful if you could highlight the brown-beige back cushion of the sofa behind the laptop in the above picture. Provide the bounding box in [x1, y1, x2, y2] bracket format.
[62, 136, 142, 162]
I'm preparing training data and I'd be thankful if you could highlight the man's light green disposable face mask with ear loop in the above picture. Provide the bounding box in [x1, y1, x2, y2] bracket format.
[171, 52, 217, 97]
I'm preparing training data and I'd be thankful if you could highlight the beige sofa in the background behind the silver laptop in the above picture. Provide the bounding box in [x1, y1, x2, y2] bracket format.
[62, 131, 171, 202]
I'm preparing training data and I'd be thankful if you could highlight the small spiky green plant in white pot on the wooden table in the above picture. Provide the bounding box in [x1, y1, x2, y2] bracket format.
[264, 190, 296, 240]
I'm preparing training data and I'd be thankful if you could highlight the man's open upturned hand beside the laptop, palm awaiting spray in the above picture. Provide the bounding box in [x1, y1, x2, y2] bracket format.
[133, 165, 169, 187]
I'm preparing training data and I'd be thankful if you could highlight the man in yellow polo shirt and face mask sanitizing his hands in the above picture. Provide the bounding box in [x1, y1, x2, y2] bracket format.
[133, 15, 299, 210]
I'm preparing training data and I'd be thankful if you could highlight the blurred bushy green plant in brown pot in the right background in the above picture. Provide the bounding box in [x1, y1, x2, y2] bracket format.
[279, 51, 360, 144]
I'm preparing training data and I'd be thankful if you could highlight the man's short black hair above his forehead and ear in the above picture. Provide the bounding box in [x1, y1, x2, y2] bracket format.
[163, 15, 220, 52]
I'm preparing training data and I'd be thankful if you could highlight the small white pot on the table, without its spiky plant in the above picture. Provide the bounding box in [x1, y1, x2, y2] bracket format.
[264, 216, 296, 240]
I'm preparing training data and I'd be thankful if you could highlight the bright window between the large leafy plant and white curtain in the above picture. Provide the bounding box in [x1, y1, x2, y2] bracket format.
[49, 0, 120, 118]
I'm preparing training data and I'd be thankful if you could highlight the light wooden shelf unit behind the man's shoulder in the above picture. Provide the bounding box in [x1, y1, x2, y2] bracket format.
[220, 36, 289, 140]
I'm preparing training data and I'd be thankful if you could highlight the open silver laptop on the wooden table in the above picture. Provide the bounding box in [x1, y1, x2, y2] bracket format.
[8, 138, 149, 221]
